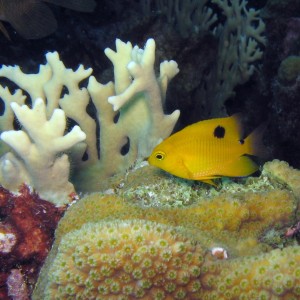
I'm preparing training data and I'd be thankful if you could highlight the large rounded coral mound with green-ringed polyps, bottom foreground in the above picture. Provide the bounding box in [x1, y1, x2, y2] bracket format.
[45, 220, 204, 299]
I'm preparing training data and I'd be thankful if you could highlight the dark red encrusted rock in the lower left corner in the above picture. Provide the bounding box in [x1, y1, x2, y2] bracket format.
[0, 185, 63, 299]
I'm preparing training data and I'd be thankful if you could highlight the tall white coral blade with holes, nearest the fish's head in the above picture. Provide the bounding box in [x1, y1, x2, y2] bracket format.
[74, 39, 179, 191]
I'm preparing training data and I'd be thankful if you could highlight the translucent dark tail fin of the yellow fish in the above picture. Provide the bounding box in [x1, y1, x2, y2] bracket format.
[245, 122, 268, 158]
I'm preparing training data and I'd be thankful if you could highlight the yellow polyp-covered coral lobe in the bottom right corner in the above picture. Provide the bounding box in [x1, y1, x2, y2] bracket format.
[200, 246, 300, 300]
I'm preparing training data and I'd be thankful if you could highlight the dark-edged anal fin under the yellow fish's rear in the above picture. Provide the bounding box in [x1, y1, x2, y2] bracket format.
[220, 155, 258, 177]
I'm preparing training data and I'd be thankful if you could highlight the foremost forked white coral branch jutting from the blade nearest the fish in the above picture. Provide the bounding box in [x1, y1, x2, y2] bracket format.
[105, 39, 179, 157]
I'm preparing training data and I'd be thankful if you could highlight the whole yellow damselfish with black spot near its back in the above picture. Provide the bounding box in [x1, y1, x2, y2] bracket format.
[148, 114, 265, 185]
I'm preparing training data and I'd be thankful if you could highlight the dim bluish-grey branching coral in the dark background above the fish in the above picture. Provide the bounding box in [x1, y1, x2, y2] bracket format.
[140, 0, 266, 120]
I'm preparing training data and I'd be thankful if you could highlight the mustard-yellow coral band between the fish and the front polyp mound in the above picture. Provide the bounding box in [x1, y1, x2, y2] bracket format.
[48, 183, 296, 256]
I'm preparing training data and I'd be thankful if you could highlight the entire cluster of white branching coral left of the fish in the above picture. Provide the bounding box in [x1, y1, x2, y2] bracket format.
[0, 39, 179, 205]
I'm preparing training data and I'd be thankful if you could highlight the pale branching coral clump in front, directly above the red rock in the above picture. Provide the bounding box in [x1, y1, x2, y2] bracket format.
[0, 98, 86, 205]
